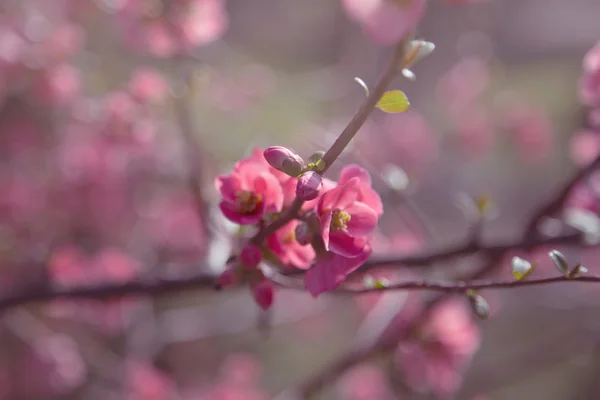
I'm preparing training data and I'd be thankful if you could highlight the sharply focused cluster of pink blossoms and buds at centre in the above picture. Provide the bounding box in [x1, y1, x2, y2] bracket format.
[216, 146, 383, 308]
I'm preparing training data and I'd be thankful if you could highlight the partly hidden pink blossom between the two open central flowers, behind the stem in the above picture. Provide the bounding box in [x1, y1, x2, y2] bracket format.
[267, 220, 315, 269]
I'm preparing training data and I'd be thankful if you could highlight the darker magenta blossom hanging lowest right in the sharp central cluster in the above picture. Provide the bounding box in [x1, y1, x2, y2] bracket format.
[304, 244, 372, 297]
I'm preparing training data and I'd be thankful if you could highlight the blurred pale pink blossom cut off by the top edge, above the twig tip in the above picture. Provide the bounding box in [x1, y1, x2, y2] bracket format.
[342, 0, 426, 45]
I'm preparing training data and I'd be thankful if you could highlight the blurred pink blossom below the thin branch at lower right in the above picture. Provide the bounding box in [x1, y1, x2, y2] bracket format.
[396, 300, 480, 398]
